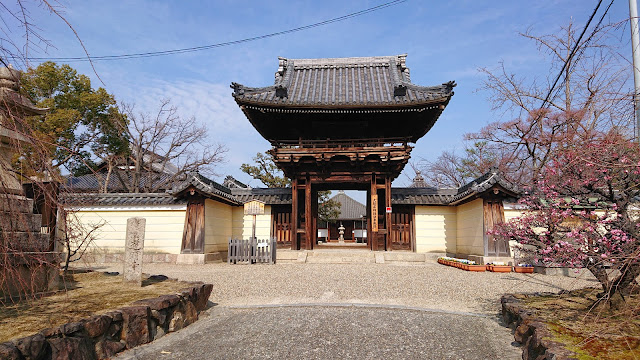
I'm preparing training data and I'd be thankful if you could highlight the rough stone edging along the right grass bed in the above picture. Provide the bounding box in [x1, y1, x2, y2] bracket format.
[500, 294, 577, 360]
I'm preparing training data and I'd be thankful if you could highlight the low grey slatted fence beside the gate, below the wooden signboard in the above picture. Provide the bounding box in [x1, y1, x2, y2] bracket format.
[227, 237, 276, 264]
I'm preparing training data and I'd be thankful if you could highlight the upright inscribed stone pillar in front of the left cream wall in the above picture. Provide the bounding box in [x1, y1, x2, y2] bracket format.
[123, 217, 147, 286]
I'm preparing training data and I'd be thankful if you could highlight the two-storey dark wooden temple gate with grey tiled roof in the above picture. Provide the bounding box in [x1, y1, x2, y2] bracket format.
[232, 54, 455, 250]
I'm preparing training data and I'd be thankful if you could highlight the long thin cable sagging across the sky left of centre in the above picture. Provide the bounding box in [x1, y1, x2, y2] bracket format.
[29, 0, 408, 62]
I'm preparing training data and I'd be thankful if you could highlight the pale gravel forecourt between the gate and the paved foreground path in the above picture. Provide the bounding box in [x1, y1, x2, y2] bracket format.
[90, 259, 596, 315]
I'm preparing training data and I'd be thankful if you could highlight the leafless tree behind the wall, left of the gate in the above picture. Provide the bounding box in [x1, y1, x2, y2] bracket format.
[97, 100, 227, 193]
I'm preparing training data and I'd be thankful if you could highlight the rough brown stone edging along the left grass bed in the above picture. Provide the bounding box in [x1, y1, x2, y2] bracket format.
[0, 283, 213, 360]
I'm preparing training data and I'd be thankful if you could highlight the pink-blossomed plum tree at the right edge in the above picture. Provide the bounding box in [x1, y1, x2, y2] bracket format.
[490, 131, 640, 307]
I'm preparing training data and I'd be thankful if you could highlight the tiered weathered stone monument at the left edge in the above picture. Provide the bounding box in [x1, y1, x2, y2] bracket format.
[0, 67, 60, 297]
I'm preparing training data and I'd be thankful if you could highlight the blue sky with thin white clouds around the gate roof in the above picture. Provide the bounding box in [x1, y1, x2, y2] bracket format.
[10, 0, 631, 187]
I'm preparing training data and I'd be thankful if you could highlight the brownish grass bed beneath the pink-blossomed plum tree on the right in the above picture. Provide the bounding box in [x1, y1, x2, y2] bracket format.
[523, 288, 640, 360]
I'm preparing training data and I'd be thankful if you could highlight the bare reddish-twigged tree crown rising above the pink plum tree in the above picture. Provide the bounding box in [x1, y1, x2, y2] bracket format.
[466, 23, 633, 182]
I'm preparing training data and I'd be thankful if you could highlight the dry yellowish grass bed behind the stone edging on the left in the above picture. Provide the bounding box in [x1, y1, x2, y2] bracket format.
[0, 272, 189, 343]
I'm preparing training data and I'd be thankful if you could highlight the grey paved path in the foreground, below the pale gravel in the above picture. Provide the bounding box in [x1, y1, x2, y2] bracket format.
[117, 304, 521, 360]
